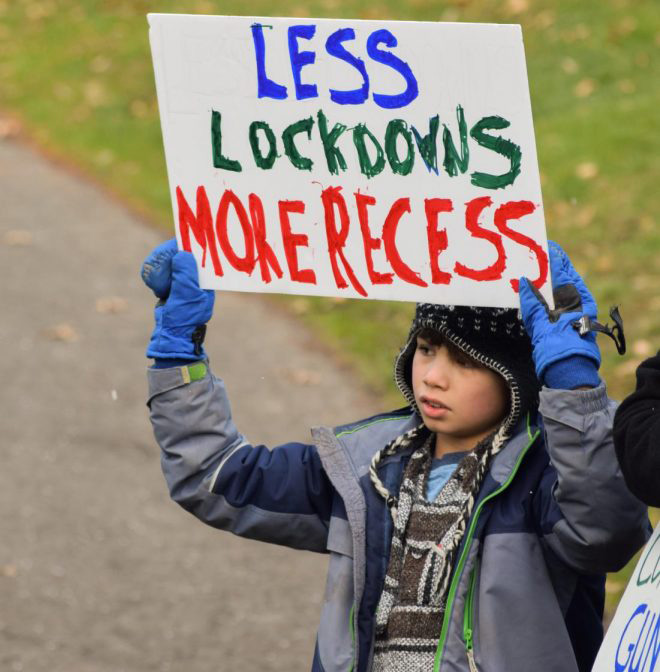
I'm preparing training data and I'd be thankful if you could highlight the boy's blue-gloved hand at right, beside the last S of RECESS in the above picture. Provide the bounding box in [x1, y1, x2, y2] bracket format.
[519, 242, 600, 381]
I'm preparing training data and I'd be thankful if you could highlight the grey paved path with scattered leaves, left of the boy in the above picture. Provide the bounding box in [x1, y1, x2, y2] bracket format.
[0, 140, 374, 672]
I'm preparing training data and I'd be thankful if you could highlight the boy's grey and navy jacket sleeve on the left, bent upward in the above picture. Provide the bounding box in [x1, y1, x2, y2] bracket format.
[148, 367, 334, 552]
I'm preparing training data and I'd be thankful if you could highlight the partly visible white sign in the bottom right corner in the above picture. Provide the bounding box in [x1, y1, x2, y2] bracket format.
[593, 525, 660, 672]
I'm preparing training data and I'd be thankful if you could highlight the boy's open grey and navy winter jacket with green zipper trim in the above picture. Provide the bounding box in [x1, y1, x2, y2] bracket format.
[148, 364, 649, 672]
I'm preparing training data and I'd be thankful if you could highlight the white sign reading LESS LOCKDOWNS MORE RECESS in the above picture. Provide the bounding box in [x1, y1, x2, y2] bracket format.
[148, 14, 552, 306]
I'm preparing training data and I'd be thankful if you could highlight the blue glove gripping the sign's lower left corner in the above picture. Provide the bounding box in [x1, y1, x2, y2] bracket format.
[142, 241, 215, 365]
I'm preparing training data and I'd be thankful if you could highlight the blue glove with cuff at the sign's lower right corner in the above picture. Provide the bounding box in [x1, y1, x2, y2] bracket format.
[519, 242, 600, 388]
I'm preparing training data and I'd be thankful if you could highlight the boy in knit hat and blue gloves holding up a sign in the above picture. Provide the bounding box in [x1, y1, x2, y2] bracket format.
[143, 242, 648, 672]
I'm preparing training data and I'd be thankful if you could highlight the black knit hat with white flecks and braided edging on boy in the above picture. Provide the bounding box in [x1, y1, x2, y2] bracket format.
[394, 303, 540, 432]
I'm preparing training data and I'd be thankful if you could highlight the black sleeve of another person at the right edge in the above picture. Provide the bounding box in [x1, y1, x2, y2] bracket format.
[614, 352, 660, 506]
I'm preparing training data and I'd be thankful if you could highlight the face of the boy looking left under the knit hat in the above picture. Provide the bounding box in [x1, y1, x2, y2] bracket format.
[412, 336, 508, 456]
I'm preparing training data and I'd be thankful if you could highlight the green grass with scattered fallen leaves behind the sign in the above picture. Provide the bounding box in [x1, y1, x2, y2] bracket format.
[0, 0, 660, 605]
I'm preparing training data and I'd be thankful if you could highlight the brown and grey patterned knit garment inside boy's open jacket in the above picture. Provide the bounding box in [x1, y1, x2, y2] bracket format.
[372, 426, 500, 672]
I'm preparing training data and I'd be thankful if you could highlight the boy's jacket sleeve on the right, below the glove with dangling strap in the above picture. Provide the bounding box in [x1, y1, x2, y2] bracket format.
[534, 384, 650, 574]
